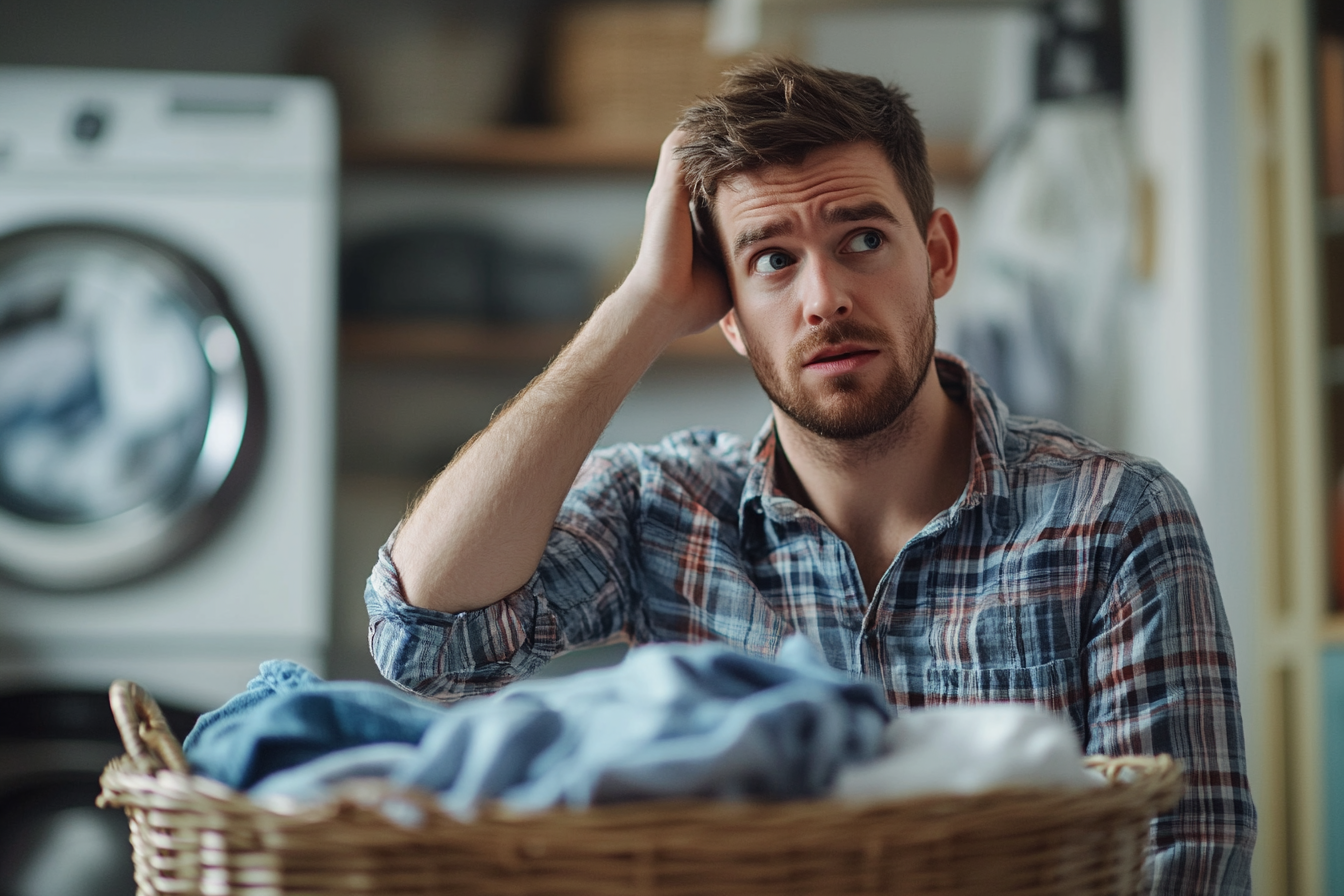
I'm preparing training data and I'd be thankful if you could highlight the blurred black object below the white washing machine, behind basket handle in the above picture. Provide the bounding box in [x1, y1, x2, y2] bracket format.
[0, 688, 196, 896]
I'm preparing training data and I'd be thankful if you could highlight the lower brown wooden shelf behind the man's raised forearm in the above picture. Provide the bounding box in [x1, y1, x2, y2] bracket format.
[340, 321, 746, 368]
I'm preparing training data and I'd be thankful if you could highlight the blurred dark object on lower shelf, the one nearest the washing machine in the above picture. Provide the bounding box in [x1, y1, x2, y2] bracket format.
[340, 224, 500, 320]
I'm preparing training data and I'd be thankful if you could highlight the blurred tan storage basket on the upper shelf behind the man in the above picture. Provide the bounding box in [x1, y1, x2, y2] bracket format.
[552, 0, 734, 137]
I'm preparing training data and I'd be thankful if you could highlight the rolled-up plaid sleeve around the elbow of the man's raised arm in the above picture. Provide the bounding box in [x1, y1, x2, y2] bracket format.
[364, 447, 638, 700]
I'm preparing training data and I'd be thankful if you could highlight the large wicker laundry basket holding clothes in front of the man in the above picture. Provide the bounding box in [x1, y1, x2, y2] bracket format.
[98, 681, 1183, 896]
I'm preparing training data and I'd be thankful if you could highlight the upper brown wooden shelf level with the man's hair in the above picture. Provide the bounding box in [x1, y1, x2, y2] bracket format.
[343, 128, 981, 183]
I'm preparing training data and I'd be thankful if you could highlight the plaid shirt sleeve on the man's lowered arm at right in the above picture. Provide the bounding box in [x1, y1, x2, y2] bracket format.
[1087, 474, 1255, 896]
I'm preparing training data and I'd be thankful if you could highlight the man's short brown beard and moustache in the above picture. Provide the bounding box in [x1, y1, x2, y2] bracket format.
[742, 285, 937, 441]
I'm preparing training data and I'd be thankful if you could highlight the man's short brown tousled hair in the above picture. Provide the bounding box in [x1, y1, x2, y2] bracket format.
[677, 56, 933, 243]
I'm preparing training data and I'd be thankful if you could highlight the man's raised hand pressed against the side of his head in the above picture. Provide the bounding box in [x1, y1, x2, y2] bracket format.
[607, 130, 732, 336]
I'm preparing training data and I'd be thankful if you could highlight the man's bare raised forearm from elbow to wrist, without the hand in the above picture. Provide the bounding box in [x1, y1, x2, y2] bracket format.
[392, 287, 676, 613]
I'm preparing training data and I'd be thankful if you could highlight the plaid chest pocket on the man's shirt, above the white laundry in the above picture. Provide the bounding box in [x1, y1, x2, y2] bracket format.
[925, 657, 1087, 744]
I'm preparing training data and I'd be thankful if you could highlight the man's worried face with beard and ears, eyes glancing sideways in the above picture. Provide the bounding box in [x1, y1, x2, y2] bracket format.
[715, 144, 957, 439]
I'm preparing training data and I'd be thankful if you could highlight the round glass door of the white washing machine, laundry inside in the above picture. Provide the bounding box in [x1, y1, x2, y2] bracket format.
[0, 226, 265, 590]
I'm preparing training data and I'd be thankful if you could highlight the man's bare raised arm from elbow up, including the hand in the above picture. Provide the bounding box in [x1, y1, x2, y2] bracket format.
[391, 132, 730, 613]
